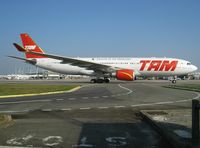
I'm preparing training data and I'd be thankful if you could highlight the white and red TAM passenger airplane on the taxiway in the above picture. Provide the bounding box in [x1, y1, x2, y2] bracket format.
[8, 33, 198, 83]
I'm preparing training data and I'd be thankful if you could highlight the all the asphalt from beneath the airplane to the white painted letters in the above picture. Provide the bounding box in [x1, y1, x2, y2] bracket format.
[0, 80, 200, 148]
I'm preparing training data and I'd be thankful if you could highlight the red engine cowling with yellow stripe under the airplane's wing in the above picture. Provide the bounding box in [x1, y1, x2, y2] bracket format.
[116, 69, 135, 81]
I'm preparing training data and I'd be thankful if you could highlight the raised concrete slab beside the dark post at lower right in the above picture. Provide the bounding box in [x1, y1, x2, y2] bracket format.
[141, 109, 200, 148]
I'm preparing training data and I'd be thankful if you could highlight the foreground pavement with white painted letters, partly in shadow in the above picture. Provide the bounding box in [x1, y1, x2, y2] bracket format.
[0, 108, 170, 148]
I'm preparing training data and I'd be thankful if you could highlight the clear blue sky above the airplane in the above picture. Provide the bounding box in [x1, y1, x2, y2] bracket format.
[0, 0, 200, 74]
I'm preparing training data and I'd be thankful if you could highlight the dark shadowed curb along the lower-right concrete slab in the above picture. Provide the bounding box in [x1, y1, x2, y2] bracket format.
[140, 111, 191, 148]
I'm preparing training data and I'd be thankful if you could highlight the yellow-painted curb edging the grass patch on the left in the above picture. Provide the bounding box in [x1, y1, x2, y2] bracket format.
[0, 86, 81, 99]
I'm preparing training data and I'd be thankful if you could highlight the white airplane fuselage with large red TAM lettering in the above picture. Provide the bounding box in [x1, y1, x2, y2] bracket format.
[33, 57, 197, 76]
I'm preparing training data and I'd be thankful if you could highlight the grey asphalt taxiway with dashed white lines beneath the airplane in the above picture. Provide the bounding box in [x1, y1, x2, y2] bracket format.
[0, 80, 200, 112]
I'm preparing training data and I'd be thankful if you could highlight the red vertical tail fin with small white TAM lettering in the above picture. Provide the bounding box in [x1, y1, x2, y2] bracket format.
[20, 34, 46, 59]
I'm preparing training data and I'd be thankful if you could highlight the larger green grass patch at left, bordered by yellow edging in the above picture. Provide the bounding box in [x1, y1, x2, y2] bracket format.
[0, 84, 77, 96]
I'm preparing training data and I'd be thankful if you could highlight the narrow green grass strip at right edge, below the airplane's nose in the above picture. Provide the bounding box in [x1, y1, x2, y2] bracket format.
[163, 84, 200, 92]
